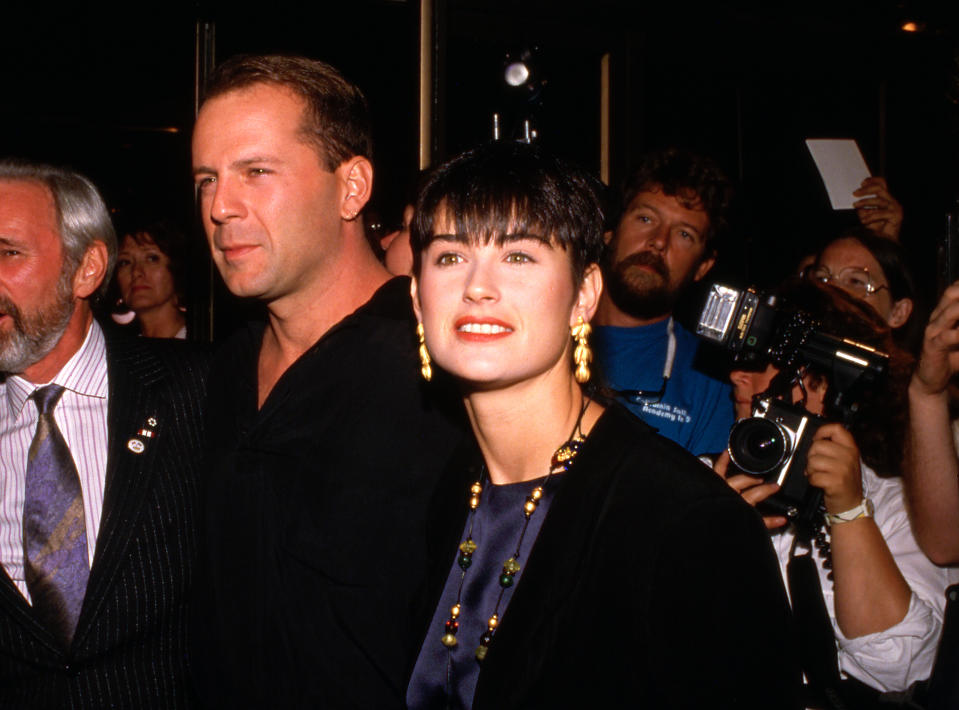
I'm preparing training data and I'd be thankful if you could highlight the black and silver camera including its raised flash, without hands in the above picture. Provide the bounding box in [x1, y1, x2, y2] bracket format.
[696, 284, 889, 531]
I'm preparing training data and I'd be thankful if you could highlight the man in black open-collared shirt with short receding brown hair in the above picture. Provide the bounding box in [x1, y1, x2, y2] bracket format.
[193, 56, 459, 708]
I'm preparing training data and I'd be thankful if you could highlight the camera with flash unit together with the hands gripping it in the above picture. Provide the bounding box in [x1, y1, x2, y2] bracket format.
[697, 284, 888, 535]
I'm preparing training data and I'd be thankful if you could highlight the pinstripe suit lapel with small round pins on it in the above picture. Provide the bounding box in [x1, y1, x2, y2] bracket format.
[74, 337, 168, 648]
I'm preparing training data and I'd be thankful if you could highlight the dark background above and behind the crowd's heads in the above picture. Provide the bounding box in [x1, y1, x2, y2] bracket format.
[0, 0, 959, 334]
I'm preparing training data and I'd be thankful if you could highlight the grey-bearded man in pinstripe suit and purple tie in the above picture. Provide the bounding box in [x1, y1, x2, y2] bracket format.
[0, 161, 206, 709]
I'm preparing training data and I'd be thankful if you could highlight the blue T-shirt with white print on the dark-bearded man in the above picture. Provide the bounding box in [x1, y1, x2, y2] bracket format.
[593, 318, 735, 454]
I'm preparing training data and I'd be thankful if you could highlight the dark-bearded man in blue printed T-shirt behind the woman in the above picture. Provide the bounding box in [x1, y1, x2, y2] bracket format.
[595, 149, 733, 454]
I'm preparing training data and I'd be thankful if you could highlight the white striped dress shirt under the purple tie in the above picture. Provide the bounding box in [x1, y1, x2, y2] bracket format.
[0, 321, 107, 601]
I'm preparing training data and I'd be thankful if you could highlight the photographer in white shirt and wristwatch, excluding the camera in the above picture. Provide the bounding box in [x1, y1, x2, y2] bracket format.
[716, 283, 950, 708]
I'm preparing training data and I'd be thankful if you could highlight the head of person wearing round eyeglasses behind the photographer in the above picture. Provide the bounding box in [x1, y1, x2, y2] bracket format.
[803, 227, 922, 353]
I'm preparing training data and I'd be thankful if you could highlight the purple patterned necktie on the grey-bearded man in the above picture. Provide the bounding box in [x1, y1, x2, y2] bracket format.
[23, 385, 90, 648]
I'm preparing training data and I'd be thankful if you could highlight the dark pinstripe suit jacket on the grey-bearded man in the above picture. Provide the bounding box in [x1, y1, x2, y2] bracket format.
[0, 337, 207, 710]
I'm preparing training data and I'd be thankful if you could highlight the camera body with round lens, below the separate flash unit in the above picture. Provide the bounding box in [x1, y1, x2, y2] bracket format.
[728, 397, 826, 525]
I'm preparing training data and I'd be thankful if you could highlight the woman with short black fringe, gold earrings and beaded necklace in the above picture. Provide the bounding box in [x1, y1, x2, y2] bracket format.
[407, 142, 799, 709]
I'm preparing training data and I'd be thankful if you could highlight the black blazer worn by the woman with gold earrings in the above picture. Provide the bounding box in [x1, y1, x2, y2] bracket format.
[426, 407, 800, 710]
